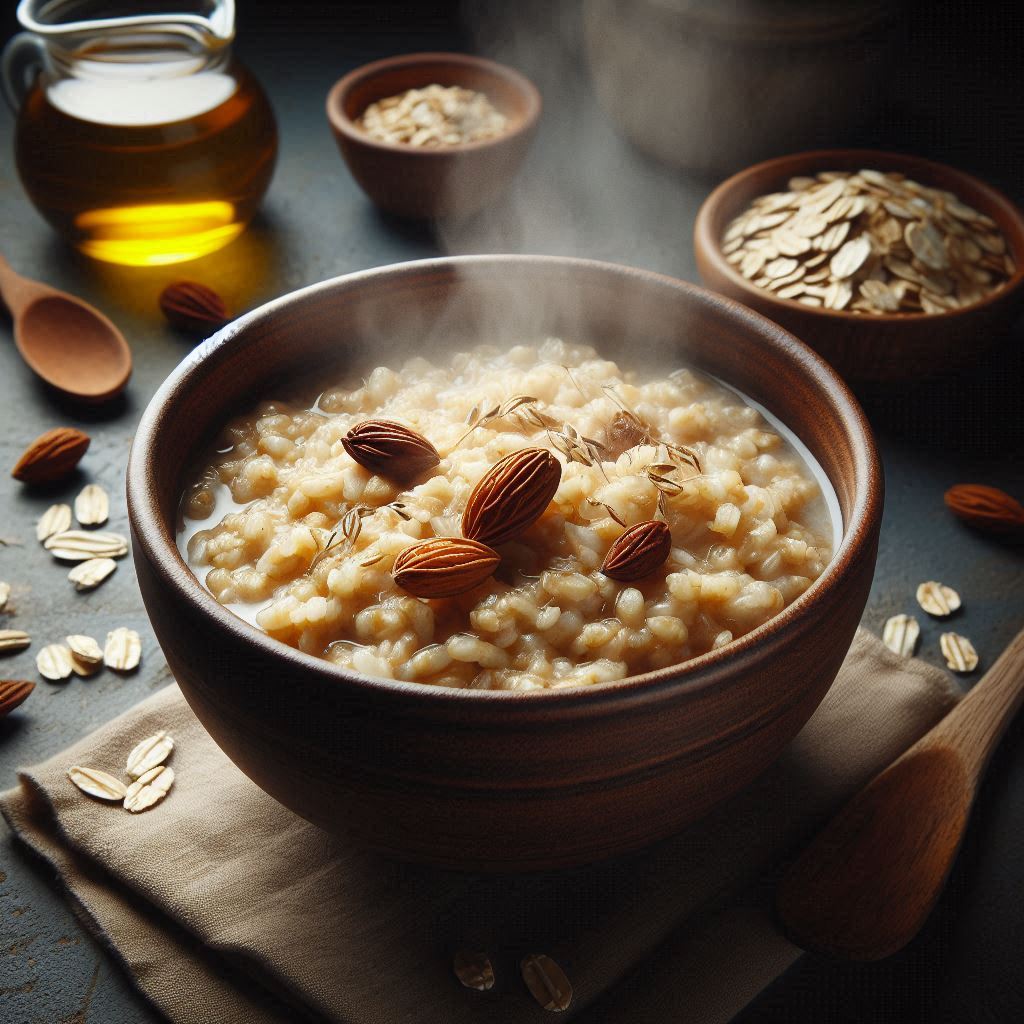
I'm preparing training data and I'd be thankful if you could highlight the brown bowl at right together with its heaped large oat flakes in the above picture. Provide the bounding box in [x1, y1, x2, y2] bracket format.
[693, 150, 1024, 382]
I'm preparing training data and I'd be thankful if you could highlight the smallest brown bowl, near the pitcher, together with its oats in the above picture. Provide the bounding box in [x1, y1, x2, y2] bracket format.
[327, 53, 541, 219]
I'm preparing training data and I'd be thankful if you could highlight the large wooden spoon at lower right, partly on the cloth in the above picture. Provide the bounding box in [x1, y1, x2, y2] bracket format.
[776, 630, 1024, 961]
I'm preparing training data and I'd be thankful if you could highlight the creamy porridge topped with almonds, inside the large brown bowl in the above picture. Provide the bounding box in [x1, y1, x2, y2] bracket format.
[179, 339, 835, 689]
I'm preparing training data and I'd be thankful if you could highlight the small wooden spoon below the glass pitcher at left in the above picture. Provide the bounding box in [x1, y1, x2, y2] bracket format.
[0, 256, 131, 401]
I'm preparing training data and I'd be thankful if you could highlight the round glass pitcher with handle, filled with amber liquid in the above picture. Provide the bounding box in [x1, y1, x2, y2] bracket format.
[3, 0, 278, 265]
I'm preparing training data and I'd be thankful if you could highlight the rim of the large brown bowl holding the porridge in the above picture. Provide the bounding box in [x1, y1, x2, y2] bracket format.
[126, 254, 883, 722]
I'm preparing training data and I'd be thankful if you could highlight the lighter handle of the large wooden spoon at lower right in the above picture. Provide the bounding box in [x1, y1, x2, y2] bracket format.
[920, 618, 1024, 778]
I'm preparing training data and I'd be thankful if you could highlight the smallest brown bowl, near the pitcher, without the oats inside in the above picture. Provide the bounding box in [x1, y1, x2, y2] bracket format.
[327, 53, 541, 219]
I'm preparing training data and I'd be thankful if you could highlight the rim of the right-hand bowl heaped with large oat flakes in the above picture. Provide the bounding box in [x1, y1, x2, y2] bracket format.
[693, 148, 1024, 325]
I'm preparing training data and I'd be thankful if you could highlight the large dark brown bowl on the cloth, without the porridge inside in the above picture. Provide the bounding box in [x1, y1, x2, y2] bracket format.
[128, 256, 882, 869]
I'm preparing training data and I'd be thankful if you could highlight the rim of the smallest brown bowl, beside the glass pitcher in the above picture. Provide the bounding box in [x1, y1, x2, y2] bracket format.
[326, 50, 543, 160]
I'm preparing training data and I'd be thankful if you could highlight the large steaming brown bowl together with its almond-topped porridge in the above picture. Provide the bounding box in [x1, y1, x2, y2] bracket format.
[128, 256, 882, 870]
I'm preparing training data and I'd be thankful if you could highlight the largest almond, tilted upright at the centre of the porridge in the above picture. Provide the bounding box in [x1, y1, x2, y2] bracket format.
[462, 449, 562, 547]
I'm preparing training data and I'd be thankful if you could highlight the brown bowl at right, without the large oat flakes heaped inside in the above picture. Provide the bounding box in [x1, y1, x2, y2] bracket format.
[693, 150, 1024, 383]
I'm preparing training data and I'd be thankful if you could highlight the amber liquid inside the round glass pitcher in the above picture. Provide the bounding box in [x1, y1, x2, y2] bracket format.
[15, 61, 278, 266]
